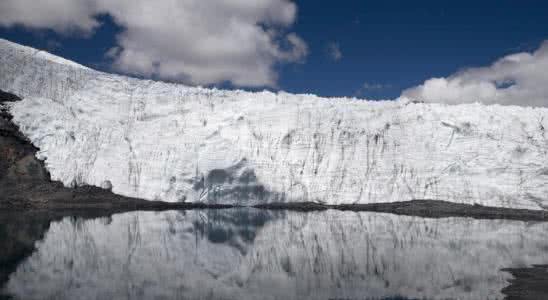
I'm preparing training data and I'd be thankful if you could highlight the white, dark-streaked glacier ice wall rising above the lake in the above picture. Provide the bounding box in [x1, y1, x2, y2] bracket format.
[0, 40, 548, 209]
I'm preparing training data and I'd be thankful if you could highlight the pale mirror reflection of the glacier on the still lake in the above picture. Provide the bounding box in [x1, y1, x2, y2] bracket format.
[2, 209, 548, 299]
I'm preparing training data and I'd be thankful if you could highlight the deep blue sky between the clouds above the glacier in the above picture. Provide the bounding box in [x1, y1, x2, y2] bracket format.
[0, 0, 548, 99]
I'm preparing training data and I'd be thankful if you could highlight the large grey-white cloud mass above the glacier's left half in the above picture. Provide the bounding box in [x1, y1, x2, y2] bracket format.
[0, 0, 308, 86]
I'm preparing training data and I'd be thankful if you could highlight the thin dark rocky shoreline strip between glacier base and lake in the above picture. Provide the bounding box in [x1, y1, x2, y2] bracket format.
[0, 199, 548, 222]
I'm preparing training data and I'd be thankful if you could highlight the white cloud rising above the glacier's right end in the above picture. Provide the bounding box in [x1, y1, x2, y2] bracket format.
[402, 41, 548, 106]
